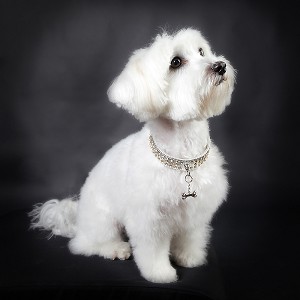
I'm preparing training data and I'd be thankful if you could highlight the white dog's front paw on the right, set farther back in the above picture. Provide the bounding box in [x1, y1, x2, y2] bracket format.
[173, 250, 206, 268]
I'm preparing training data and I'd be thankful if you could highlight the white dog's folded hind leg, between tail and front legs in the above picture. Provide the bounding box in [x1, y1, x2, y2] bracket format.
[69, 195, 131, 259]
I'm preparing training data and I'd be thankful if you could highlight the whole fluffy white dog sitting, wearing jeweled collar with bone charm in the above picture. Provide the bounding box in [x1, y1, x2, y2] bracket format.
[30, 28, 235, 283]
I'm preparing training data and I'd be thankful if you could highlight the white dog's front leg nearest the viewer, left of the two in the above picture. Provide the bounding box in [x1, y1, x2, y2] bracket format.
[130, 234, 177, 283]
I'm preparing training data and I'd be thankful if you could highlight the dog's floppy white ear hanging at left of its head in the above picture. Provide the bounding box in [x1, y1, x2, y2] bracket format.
[108, 38, 167, 121]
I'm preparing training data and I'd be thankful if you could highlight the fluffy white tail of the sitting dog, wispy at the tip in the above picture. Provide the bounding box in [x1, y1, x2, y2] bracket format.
[28, 197, 78, 238]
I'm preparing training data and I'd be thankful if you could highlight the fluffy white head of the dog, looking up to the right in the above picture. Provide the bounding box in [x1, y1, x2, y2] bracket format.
[108, 28, 235, 121]
